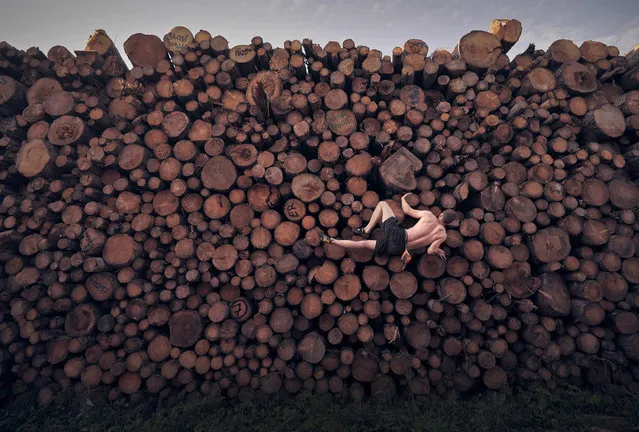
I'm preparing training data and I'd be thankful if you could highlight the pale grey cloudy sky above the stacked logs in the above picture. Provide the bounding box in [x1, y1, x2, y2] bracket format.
[0, 0, 639, 66]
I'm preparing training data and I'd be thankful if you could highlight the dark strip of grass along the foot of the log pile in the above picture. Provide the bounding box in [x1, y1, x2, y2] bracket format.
[0, 387, 639, 432]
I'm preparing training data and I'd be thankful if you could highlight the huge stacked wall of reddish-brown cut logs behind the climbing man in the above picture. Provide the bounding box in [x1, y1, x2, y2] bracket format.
[0, 20, 639, 404]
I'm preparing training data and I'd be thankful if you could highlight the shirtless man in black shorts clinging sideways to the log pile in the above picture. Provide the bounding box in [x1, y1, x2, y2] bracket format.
[320, 194, 457, 267]
